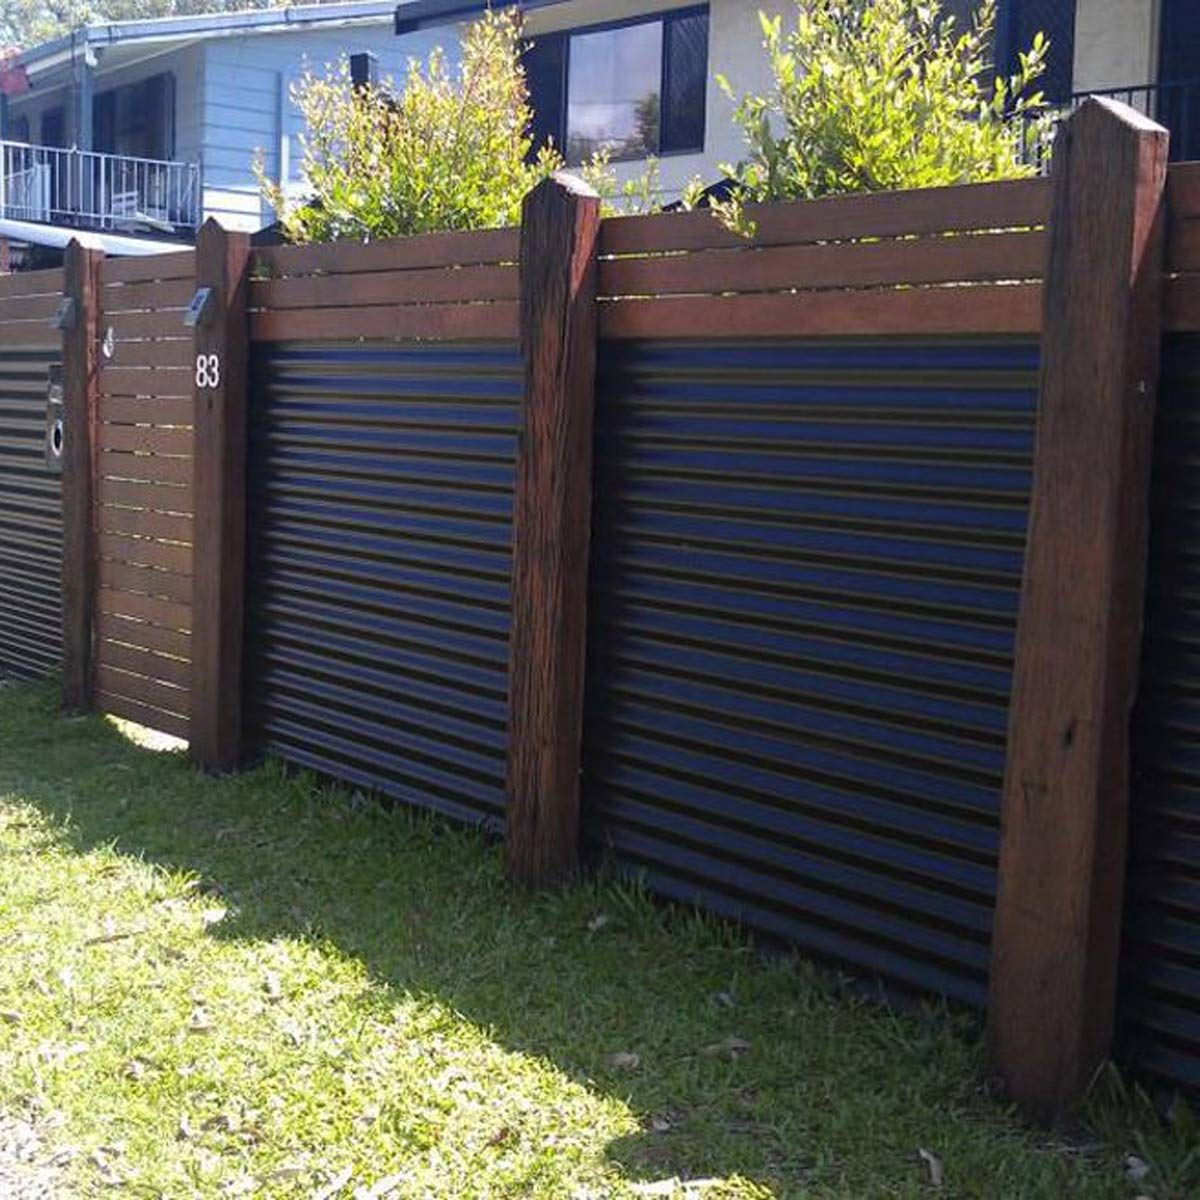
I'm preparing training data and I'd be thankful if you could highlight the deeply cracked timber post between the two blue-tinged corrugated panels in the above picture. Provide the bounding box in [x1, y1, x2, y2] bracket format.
[506, 174, 600, 887]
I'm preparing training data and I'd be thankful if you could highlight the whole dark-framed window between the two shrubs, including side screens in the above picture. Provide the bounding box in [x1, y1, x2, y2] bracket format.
[524, 8, 708, 163]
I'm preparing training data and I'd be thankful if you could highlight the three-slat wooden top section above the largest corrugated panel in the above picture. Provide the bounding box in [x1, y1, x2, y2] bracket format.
[600, 179, 1050, 338]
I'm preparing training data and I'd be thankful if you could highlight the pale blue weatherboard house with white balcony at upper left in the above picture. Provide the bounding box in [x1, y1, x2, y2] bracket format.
[0, 2, 422, 245]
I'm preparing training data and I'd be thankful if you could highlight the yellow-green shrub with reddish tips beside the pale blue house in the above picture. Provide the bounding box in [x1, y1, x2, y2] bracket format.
[259, 12, 562, 241]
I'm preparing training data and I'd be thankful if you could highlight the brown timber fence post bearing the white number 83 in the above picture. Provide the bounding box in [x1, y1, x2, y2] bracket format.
[191, 220, 250, 772]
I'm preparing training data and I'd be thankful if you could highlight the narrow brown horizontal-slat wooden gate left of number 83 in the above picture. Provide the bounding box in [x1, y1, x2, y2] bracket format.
[94, 253, 196, 738]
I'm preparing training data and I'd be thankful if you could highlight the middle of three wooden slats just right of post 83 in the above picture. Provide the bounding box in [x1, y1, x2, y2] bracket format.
[250, 266, 517, 308]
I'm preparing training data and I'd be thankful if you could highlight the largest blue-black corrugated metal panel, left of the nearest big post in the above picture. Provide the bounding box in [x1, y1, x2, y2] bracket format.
[584, 340, 1037, 1004]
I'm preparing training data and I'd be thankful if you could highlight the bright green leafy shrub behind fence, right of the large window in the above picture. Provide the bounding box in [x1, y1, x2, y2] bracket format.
[718, 0, 1048, 232]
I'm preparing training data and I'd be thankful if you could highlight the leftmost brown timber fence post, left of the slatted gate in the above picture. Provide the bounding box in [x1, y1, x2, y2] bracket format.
[62, 241, 104, 712]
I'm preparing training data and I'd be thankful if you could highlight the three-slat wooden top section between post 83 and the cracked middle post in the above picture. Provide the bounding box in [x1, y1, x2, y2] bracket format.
[250, 229, 520, 341]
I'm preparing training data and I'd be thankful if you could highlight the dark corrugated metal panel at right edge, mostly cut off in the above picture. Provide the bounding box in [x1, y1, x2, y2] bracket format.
[1121, 336, 1200, 1090]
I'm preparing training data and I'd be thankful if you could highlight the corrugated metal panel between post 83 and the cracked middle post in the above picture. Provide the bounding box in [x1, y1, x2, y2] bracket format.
[248, 343, 521, 829]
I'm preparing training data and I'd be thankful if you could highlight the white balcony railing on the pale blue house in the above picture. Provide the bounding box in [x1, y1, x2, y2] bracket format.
[0, 142, 200, 232]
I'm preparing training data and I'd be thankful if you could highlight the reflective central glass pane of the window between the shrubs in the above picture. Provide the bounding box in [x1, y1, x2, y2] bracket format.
[566, 22, 662, 163]
